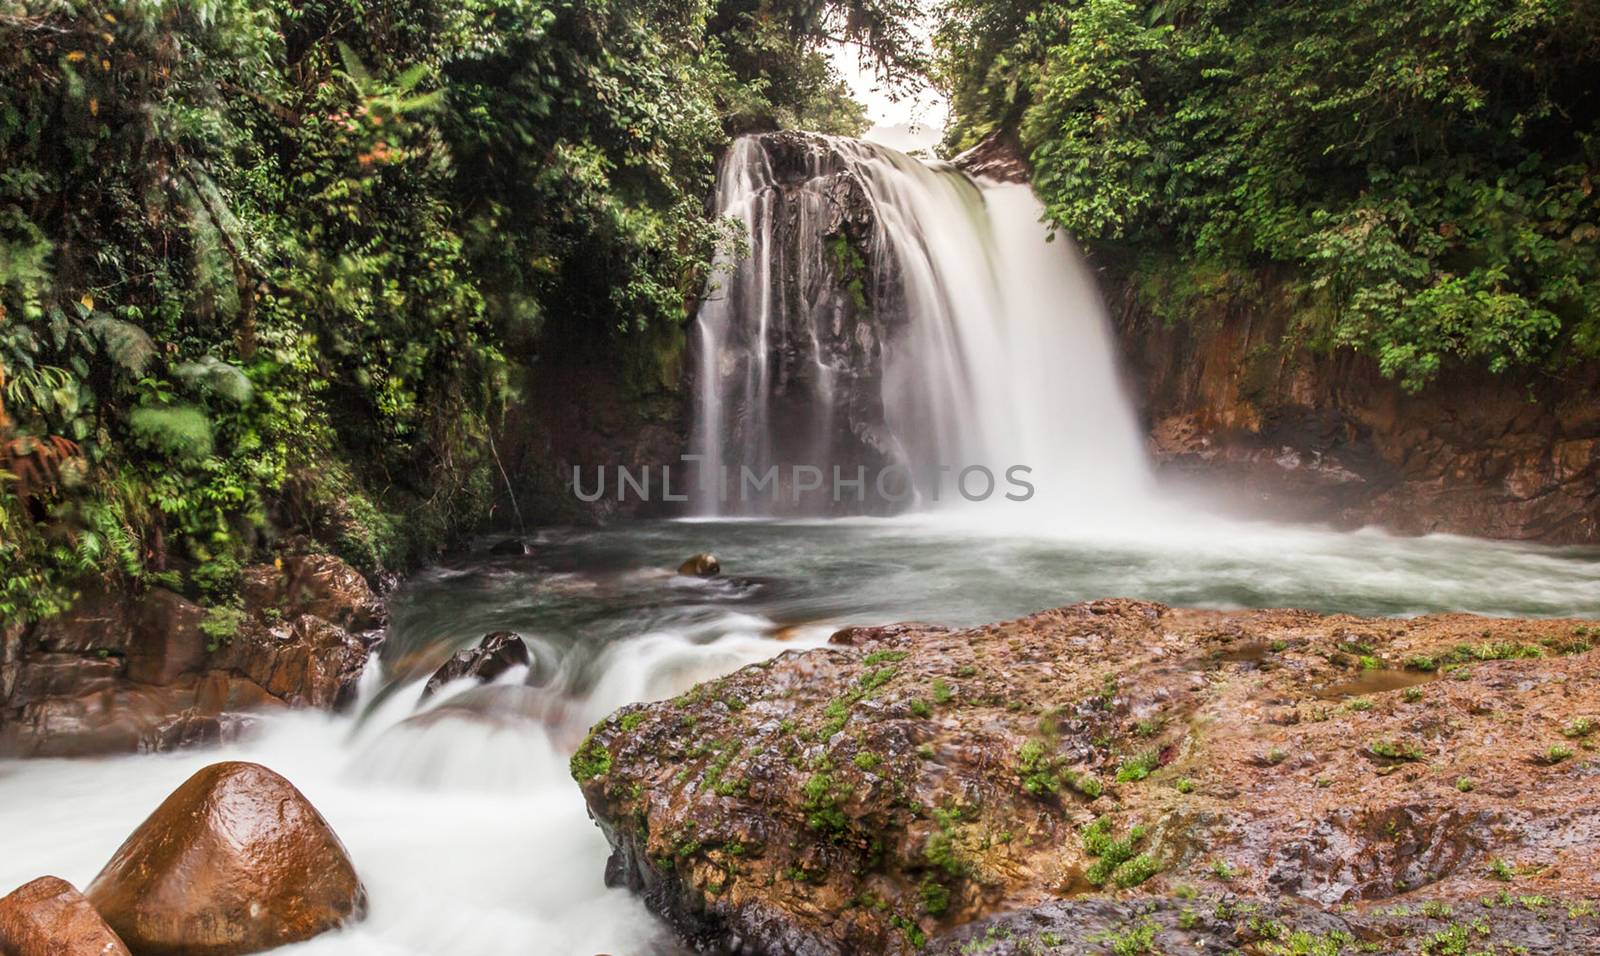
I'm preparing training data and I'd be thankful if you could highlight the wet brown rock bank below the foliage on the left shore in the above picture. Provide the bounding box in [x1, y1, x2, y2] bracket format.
[0, 555, 384, 756]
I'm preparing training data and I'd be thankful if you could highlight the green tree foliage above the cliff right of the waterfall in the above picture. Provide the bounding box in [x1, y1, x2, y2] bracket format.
[936, 0, 1600, 390]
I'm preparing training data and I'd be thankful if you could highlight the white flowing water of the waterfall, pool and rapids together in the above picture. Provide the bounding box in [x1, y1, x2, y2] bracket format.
[0, 141, 1600, 956]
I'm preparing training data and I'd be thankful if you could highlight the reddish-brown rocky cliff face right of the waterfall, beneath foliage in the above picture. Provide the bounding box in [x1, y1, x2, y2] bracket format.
[1102, 276, 1600, 544]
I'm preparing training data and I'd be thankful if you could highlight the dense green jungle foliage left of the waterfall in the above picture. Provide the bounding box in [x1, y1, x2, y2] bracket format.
[0, 0, 889, 620]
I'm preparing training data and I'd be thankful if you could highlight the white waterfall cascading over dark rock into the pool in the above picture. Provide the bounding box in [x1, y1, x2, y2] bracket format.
[691, 133, 1150, 515]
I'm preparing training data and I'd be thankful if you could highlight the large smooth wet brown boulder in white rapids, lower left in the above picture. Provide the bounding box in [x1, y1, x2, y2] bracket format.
[86, 763, 366, 956]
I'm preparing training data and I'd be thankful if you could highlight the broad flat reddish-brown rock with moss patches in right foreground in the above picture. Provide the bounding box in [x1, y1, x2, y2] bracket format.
[573, 601, 1600, 953]
